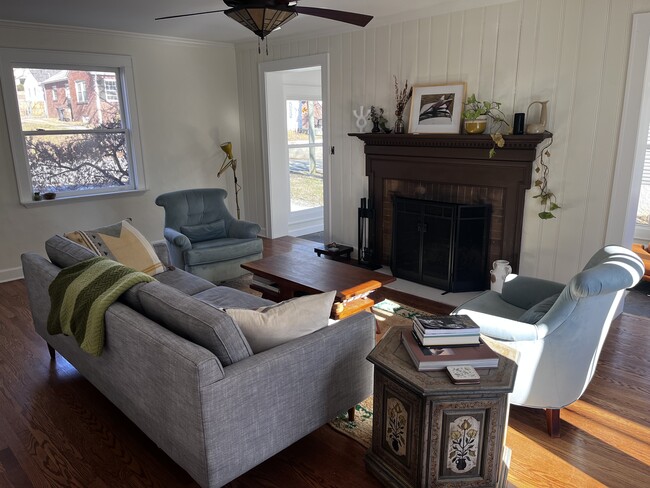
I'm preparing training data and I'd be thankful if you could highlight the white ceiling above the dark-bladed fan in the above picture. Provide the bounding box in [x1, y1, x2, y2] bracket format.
[0, 0, 498, 43]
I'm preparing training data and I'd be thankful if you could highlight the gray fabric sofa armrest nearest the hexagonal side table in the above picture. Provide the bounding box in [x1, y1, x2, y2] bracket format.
[197, 313, 375, 486]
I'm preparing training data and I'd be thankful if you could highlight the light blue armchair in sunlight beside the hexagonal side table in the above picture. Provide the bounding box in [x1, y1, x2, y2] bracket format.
[452, 246, 644, 437]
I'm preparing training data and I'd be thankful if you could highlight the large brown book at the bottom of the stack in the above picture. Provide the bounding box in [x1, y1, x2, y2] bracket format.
[402, 332, 499, 371]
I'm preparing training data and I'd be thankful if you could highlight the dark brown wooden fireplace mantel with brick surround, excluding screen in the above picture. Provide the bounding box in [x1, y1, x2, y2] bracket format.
[348, 132, 552, 272]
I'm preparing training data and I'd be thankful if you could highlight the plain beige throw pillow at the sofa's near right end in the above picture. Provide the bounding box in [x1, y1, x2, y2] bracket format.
[226, 291, 336, 354]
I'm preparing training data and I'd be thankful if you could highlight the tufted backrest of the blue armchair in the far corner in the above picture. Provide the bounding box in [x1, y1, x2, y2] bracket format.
[156, 188, 235, 232]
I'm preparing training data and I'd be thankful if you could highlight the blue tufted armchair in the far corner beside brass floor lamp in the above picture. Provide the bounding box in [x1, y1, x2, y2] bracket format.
[156, 188, 262, 283]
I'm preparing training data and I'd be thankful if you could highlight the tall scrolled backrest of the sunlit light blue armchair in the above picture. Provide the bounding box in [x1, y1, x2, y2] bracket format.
[512, 246, 644, 408]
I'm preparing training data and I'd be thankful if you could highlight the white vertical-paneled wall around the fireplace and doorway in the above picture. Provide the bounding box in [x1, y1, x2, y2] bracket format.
[237, 0, 650, 281]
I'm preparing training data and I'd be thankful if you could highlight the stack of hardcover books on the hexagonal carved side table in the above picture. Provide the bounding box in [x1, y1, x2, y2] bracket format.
[402, 315, 499, 371]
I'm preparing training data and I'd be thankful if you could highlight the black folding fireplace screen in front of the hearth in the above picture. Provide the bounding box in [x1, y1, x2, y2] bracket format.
[391, 196, 490, 292]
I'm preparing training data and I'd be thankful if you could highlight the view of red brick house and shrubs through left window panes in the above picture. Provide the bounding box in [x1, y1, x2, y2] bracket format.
[13, 67, 131, 194]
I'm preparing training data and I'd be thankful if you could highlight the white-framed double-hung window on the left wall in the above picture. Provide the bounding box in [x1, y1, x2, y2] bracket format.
[0, 49, 144, 204]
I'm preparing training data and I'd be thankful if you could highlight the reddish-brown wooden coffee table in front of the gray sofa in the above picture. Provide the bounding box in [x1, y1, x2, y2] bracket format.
[241, 253, 395, 319]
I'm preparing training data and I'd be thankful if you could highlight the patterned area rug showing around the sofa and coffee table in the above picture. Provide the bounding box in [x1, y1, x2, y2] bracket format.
[222, 275, 423, 448]
